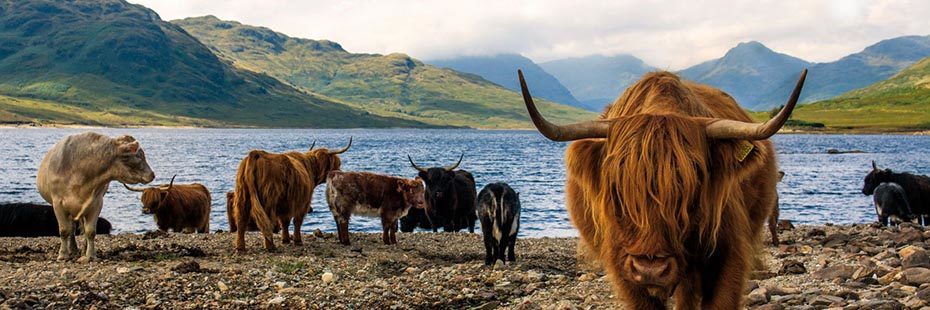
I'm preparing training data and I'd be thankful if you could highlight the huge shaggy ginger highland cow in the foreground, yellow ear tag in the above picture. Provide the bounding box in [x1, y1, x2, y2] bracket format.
[519, 70, 807, 309]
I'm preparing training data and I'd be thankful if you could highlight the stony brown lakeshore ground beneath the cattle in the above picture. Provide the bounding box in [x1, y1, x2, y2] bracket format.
[0, 225, 930, 309]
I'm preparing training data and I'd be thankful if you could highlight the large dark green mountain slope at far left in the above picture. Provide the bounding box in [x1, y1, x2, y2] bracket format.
[0, 0, 416, 127]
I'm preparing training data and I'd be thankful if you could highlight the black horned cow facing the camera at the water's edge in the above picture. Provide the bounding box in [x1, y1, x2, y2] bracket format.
[401, 154, 478, 233]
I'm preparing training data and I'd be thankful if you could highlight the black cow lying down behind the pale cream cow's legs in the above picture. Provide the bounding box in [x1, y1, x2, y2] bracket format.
[0, 203, 113, 237]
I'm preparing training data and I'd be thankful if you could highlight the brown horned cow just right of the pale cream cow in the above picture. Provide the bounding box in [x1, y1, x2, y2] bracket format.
[123, 175, 213, 234]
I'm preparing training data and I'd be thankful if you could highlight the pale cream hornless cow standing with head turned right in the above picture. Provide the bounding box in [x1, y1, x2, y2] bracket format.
[36, 132, 155, 262]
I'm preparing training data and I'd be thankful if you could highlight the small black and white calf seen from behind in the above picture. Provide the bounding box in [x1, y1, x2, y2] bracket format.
[478, 183, 520, 265]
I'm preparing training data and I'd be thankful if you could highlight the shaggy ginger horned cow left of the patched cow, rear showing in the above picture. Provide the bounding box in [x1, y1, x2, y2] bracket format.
[233, 137, 352, 252]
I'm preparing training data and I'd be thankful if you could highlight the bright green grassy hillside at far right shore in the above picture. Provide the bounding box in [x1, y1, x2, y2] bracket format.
[793, 58, 930, 130]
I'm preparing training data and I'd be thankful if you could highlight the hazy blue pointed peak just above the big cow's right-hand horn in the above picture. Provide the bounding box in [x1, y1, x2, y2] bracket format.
[679, 41, 814, 110]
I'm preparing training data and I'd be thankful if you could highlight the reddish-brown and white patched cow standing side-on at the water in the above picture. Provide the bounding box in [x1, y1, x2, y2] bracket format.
[326, 171, 426, 245]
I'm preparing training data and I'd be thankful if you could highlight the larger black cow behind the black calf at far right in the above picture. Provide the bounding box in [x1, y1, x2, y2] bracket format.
[862, 161, 930, 224]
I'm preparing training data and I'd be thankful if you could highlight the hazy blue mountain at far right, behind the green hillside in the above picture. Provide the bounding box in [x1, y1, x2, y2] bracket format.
[761, 36, 930, 107]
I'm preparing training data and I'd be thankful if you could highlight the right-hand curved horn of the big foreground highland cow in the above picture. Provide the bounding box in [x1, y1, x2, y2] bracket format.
[705, 69, 807, 140]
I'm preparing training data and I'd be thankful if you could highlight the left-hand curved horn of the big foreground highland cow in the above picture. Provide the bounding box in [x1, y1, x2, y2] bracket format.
[517, 70, 610, 141]
